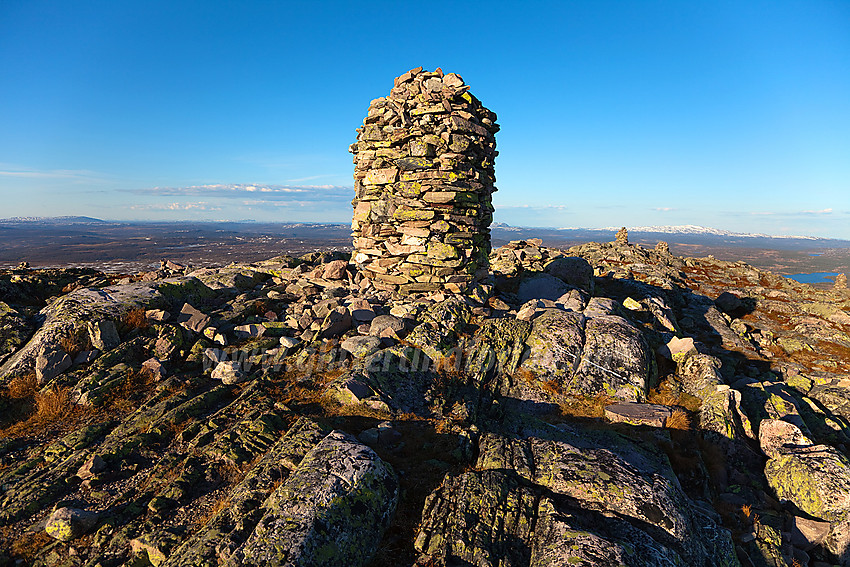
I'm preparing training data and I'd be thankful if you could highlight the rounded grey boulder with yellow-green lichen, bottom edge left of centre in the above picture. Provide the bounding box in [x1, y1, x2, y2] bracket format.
[228, 431, 398, 567]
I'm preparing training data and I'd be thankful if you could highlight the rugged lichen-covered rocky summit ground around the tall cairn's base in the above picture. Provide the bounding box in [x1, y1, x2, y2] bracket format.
[0, 238, 850, 567]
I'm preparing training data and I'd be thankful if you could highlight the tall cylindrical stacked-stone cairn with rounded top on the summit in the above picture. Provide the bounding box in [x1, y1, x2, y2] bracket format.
[349, 67, 499, 294]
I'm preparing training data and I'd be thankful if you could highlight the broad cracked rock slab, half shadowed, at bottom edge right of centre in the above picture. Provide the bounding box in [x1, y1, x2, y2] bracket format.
[415, 428, 738, 567]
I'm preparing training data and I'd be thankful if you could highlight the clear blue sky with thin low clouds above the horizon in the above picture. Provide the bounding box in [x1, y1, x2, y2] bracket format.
[0, 0, 850, 239]
